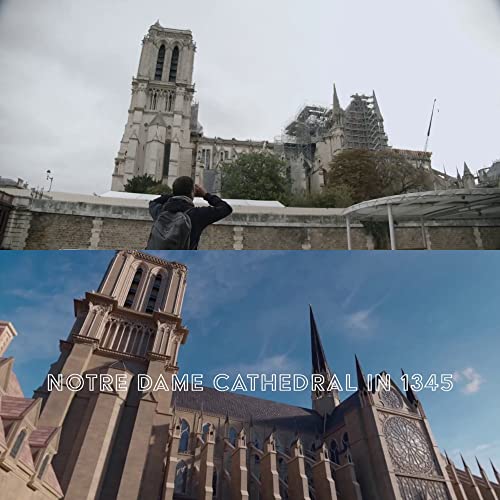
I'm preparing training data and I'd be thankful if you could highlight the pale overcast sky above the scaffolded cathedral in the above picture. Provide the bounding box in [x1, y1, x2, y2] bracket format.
[0, 0, 500, 193]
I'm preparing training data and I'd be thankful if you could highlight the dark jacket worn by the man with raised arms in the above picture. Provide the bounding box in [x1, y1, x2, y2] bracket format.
[149, 193, 233, 250]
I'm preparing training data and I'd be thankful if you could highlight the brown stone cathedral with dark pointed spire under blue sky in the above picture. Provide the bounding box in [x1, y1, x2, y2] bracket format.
[0, 251, 500, 500]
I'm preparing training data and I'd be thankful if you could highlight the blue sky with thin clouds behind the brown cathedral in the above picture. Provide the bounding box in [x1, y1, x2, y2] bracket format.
[0, 251, 500, 476]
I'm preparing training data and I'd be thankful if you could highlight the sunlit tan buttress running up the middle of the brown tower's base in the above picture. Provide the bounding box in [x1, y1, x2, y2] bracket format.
[65, 368, 132, 500]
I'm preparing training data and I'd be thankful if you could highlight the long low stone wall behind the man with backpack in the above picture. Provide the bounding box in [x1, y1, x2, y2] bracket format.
[1, 190, 500, 250]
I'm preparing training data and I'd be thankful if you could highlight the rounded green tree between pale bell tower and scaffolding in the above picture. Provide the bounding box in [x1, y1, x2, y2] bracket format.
[221, 151, 291, 204]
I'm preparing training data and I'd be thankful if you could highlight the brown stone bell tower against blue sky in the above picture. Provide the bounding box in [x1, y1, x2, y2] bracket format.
[36, 251, 188, 500]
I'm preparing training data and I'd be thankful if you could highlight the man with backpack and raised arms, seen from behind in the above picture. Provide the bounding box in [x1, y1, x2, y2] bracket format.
[146, 177, 233, 250]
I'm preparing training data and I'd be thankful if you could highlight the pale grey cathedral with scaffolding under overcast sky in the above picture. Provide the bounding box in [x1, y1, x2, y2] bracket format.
[111, 22, 438, 193]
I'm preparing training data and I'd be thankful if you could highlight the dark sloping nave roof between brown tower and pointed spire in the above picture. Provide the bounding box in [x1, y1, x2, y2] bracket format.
[173, 387, 323, 433]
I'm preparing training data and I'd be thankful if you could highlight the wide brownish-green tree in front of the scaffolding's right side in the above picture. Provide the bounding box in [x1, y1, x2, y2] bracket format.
[325, 149, 432, 203]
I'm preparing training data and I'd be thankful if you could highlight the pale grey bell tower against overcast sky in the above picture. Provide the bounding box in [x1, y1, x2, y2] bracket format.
[111, 22, 196, 191]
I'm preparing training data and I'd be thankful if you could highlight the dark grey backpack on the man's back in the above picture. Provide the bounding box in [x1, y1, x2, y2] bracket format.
[146, 210, 191, 250]
